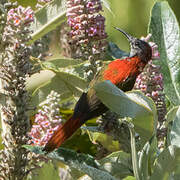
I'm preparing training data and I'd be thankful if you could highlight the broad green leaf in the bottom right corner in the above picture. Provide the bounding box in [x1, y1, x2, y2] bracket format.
[150, 145, 180, 180]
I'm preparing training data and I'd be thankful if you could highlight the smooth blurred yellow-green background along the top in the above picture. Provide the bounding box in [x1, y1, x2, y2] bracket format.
[12, 0, 180, 51]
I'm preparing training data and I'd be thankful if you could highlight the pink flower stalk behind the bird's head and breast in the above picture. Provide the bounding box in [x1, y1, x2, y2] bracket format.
[134, 34, 167, 149]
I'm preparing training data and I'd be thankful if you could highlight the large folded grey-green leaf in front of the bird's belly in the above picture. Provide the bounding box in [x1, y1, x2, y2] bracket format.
[94, 81, 157, 143]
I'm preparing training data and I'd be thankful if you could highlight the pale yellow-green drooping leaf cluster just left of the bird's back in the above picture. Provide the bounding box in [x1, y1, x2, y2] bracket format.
[27, 59, 88, 106]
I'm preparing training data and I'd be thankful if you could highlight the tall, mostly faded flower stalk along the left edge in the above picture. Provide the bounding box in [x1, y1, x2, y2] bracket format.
[0, 6, 33, 180]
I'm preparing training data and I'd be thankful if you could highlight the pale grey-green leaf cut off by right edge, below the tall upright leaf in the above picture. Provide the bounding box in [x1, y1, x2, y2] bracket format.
[169, 106, 180, 147]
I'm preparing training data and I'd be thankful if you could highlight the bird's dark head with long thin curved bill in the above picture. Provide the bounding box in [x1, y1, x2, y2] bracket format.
[115, 27, 152, 63]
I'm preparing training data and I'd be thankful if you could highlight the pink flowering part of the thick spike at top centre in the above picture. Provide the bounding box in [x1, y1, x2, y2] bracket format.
[66, 0, 107, 60]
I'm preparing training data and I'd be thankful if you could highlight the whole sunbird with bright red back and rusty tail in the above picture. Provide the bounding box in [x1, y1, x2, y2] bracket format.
[43, 28, 152, 152]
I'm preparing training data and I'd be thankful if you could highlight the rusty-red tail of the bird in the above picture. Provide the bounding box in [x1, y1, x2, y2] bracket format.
[43, 117, 83, 152]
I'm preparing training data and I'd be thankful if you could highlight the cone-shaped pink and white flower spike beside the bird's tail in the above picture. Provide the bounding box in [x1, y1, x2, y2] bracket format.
[29, 91, 62, 146]
